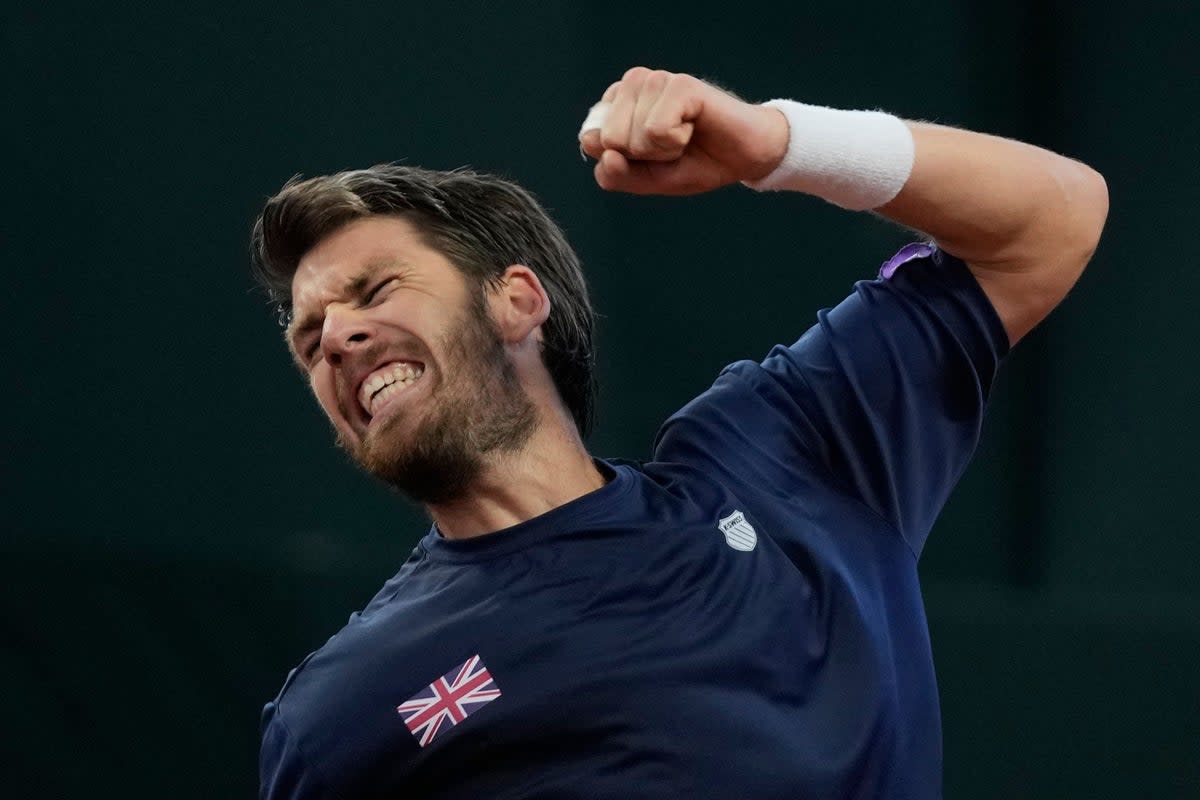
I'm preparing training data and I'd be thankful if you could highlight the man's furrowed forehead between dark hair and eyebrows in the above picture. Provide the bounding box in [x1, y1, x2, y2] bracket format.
[292, 217, 458, 319]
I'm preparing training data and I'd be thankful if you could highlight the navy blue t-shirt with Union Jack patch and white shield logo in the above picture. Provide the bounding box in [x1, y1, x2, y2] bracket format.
[262, 245, 1008, 800]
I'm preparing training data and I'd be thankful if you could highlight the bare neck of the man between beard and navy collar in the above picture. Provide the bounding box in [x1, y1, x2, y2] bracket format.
[427, 415, 605, 539]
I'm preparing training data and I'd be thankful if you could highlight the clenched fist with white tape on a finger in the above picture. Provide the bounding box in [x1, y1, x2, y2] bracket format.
[580, 67, 788, 194]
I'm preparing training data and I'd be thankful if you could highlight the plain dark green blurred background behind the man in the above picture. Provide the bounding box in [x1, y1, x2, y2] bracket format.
[0, 0, 1200, 800]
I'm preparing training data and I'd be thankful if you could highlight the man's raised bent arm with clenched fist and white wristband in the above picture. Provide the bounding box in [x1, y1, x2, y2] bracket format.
[581, 67, 1108, 343]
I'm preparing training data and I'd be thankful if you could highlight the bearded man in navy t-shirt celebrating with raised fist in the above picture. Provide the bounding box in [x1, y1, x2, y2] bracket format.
[254, 68, 1108, 800]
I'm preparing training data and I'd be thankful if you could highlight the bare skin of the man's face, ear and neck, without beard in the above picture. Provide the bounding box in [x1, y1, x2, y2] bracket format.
[288, 217, 604, 539]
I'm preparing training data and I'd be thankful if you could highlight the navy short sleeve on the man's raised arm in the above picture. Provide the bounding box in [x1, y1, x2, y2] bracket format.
[655, 245, 1008, 554]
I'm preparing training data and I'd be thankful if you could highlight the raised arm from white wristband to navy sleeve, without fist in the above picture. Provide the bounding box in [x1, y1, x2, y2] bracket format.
[749, 101, 1108, 343]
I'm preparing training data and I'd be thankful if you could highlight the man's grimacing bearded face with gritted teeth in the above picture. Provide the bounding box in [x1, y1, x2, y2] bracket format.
[288, 217, 536, 505]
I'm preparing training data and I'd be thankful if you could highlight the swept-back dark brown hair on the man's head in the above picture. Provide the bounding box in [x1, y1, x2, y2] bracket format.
[250, 164, 596, 435]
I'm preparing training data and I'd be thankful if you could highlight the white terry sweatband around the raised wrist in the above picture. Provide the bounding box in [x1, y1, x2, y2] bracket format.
[743, 100, 914, 211]
